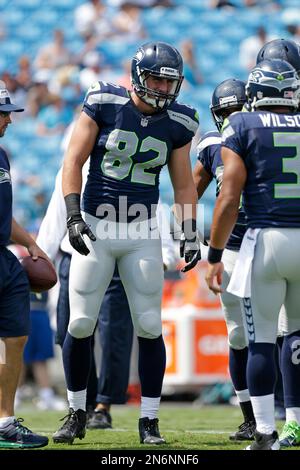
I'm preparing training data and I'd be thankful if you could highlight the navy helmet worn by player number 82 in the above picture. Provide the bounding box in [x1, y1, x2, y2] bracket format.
[131, 42, 183, 110]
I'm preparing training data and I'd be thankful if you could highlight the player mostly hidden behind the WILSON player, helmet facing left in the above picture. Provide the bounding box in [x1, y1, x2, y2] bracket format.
[194, 78, 255, 441]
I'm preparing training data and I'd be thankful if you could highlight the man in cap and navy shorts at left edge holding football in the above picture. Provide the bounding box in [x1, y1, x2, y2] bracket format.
[0, 81, 48, 449]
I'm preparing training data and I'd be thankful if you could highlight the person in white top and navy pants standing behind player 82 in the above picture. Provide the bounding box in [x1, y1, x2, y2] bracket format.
[37, 161, 178, 429]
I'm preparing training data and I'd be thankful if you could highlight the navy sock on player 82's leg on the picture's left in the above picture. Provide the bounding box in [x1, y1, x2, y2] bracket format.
[63, 332, 92, 392]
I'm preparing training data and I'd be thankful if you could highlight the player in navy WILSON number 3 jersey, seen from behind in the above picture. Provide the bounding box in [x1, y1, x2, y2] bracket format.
[206, 59, 300, 450]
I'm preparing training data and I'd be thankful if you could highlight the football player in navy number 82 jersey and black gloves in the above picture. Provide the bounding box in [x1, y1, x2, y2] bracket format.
[53, 42, 201, 444]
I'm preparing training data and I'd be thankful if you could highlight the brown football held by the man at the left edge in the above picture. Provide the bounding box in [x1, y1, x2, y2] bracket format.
[21, 256, 57, 293]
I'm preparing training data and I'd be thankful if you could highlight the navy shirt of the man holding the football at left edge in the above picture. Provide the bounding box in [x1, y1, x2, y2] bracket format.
[0, 147, 12, 246]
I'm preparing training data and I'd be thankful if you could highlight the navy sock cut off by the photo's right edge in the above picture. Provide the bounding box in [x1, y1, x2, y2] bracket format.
[281, 330, 300, 408]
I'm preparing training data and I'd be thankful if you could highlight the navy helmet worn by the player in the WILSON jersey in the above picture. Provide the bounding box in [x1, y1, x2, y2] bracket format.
[246, 59, 300, 111]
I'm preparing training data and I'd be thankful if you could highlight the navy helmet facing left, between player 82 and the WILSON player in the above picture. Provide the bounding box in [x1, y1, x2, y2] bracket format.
[210, 78, 247, 131]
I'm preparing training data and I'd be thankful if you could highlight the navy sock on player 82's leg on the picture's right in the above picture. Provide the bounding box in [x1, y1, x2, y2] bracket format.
[138, 335, 166, 398]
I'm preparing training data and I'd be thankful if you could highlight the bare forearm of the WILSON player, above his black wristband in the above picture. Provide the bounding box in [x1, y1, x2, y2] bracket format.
[210, 194, 239, 249]
